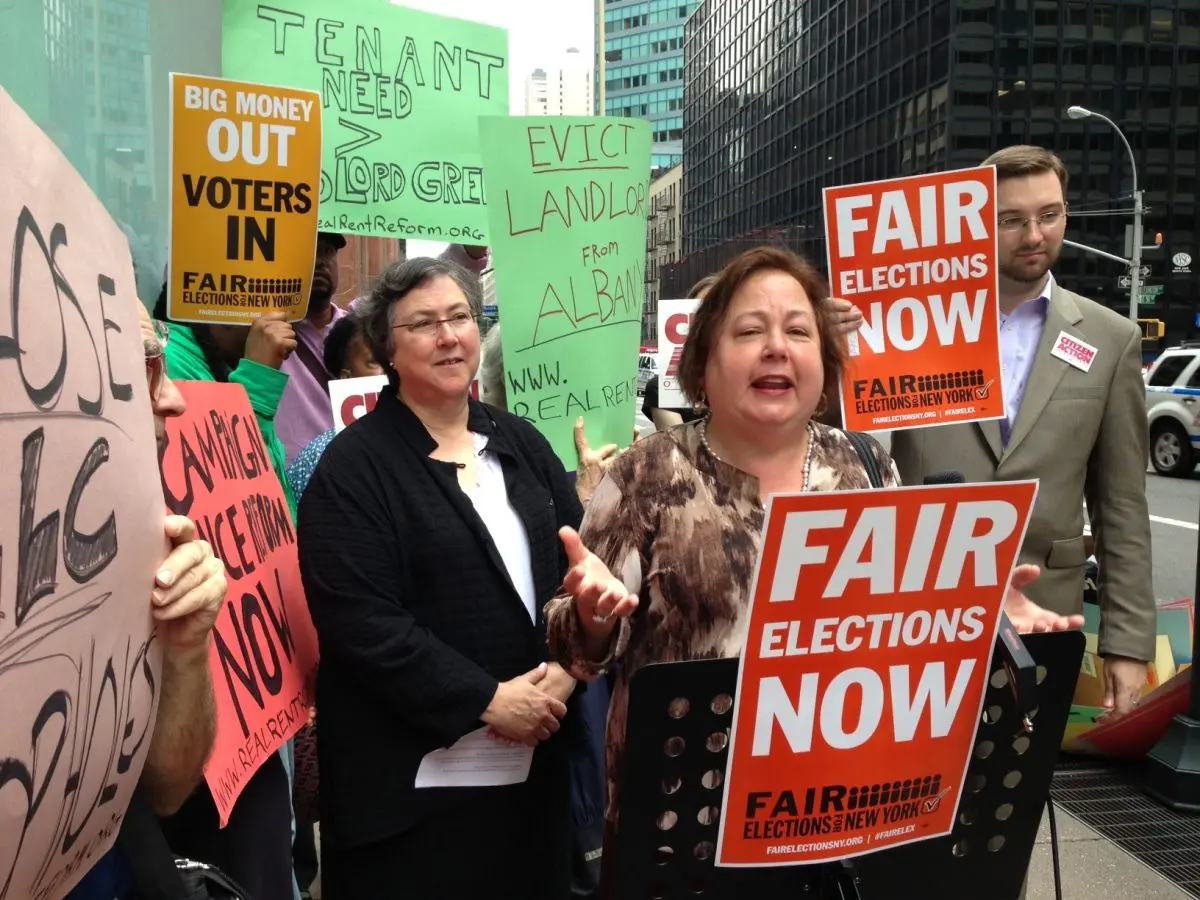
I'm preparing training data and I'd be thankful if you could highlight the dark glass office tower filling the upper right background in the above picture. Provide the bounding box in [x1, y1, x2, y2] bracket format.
[662, 0, 1200, 338]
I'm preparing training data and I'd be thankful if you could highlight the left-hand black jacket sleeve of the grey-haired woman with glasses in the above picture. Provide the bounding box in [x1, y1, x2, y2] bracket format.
[298, 438, 498, 746]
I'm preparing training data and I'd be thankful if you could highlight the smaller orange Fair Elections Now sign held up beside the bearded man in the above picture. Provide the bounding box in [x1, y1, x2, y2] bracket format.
[824, 166, 1004, 431]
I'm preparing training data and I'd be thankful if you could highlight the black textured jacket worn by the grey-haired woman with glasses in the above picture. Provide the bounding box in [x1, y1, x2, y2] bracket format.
[299, 392, 583, 846]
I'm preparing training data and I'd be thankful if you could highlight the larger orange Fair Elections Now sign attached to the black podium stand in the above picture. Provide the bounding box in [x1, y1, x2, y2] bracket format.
[716, 481, 1037, 866]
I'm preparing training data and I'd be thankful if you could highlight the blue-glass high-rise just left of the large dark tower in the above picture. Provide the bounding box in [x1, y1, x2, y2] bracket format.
[595, 0, 698, 173]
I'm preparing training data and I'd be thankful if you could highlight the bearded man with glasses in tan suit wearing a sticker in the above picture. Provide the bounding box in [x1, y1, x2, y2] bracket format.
[835, 146, 1157, 714]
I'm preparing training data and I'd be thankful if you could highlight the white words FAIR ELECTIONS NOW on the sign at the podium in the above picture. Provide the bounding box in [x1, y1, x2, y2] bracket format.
[754, 500, 1020, 756]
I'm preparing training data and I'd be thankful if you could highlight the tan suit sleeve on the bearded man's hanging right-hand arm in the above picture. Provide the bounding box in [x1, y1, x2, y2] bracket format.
[1085, 325, 1158, 661]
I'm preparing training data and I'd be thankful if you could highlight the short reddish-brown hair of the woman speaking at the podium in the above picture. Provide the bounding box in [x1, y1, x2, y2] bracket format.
[679, 247, 846, 403]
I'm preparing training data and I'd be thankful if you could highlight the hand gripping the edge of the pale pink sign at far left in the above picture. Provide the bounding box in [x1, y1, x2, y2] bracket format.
[150, 516, 227, 654]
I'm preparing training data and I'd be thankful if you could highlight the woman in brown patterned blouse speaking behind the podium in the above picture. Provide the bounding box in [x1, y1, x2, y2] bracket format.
[546, 247, 1082, 897]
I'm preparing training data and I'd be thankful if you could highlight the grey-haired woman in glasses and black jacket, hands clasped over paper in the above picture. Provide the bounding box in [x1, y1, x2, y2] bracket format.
[299, 259, 624, 900]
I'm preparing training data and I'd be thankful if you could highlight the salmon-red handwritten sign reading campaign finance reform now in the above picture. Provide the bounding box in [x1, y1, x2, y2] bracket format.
[162, 382, 317, 827]
